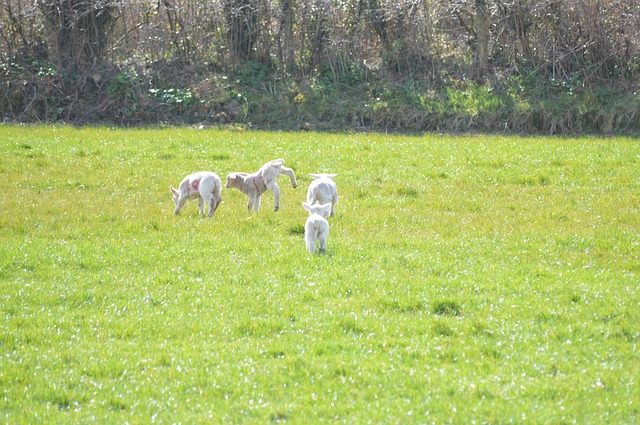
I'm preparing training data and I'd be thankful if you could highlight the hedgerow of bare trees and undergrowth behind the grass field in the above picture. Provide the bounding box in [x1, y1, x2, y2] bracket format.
[0, 0, 640, 134]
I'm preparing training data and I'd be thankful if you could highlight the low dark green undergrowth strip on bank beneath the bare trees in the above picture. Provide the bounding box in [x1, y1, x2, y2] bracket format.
[0, 58, 640, 134]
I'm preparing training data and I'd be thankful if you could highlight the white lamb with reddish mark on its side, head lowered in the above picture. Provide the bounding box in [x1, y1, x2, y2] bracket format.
[170, 171, 222, 217]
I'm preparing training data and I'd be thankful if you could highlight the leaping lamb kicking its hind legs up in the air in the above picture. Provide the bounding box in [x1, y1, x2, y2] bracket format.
[227, 159, 298, 213]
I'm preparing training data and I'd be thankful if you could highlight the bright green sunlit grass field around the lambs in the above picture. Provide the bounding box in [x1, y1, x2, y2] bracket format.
[0, 126, 640, 424]
